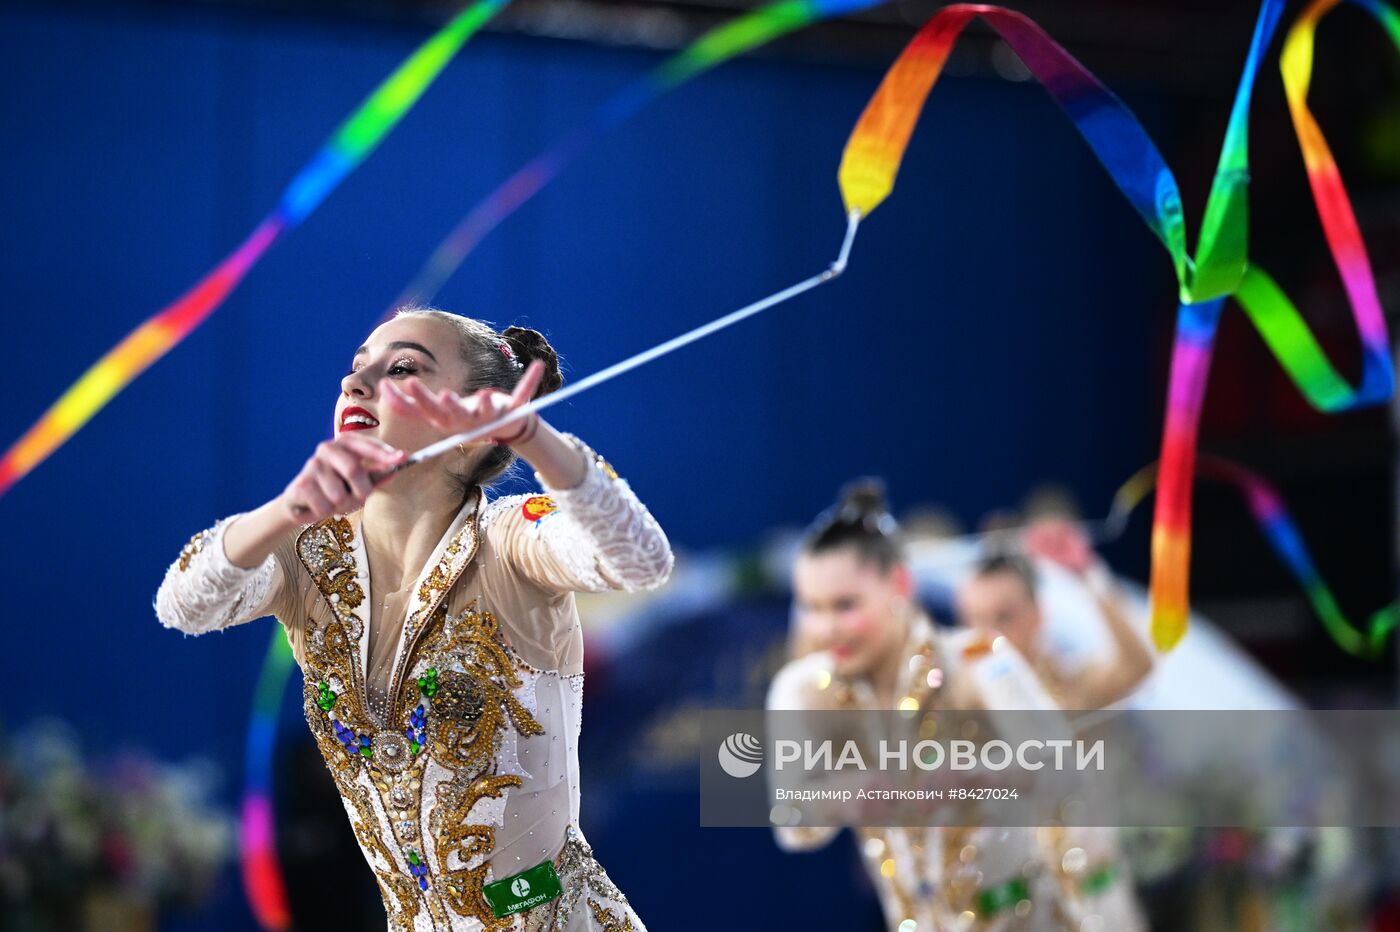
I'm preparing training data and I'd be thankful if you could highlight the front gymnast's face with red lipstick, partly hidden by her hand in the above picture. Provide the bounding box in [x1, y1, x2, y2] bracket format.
[336, 316, 468, 452]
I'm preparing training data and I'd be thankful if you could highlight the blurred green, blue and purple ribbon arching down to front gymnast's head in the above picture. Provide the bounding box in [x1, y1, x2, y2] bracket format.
[394, 0, 886, 310]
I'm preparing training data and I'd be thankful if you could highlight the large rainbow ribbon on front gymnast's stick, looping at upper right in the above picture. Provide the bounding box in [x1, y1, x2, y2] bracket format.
[840, 0, 1400, 651]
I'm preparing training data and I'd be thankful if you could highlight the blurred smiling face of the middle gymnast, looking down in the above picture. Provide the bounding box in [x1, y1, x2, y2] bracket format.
[792, 547, 913, 676]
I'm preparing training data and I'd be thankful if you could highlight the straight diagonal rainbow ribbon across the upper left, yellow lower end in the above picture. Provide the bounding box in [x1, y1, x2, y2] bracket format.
[0, 0, 510, 495]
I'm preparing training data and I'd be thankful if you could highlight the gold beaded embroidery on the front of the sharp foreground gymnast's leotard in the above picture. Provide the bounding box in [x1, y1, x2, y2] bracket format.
[298, 509, 545, 929]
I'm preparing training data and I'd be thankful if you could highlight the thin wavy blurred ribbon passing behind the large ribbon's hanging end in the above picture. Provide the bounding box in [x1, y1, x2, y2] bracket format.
[1106, 455, 1400, 661]
